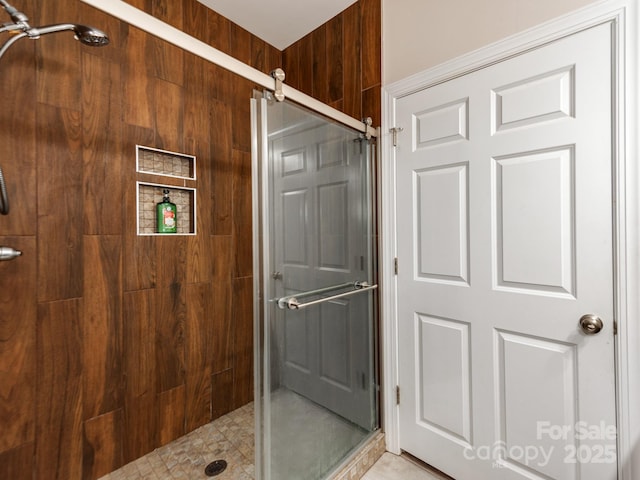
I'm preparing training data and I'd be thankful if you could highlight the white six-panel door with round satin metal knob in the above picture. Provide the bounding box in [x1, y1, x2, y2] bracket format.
[396, 24, 617, 480]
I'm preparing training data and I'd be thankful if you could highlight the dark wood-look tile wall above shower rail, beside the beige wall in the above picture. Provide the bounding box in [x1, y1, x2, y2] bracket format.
[282, 0, 382, 126]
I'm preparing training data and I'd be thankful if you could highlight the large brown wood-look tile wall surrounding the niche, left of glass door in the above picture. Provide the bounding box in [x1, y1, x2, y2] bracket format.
[0, 0, 282, 480]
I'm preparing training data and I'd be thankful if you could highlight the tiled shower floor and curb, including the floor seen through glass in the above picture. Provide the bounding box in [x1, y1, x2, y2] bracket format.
[101, 389, 376, 480]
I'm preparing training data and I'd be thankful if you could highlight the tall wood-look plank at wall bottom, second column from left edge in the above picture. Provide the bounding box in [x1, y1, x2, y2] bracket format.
[34, 299, 84, 480]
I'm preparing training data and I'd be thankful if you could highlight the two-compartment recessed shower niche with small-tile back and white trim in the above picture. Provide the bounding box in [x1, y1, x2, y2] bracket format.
[136, 145, 197, 235]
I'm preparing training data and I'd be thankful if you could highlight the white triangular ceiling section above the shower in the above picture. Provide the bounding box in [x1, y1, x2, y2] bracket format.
[198, 0, 356, 50]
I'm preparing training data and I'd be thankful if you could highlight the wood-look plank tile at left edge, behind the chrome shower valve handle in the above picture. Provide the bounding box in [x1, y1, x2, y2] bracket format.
[0, 237, 37, 452]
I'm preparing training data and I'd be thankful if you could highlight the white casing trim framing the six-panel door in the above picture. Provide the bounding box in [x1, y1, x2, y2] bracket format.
[381, 4, 640, 480]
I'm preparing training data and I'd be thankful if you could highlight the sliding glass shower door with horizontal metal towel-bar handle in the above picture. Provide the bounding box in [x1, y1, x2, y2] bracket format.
[252, 95, 378, 480]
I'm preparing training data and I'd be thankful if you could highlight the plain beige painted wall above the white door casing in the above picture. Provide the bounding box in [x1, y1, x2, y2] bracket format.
[382, 0, 594, 85]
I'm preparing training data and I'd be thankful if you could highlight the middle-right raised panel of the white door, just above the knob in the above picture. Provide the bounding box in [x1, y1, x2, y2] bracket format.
[492, 147, 576, 296]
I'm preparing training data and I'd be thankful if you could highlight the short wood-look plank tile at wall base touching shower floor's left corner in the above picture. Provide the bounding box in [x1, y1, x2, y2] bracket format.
[82, 410, 124, 480]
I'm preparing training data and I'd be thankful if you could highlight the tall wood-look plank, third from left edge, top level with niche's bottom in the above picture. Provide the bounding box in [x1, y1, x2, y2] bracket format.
[82, 235, 124, 419]
